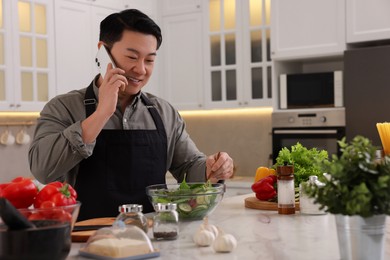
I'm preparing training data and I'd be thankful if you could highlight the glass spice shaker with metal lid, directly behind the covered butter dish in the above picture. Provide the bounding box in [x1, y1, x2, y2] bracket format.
[114, 204, 148, 233]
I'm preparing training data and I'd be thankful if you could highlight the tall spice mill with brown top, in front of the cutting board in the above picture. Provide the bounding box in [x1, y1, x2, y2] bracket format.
[276, 163, 295, 214]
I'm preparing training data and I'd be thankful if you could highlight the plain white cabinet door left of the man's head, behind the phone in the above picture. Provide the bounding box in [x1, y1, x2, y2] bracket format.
[55, 0, 117, 94]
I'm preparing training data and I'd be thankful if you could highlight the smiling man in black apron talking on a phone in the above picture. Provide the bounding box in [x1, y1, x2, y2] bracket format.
[29, 9, 233, 220]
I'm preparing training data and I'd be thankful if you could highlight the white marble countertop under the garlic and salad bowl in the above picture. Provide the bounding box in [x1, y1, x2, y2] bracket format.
[67, 194, 390, 260]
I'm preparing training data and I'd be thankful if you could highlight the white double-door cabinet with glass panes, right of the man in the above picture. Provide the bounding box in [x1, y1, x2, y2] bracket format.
[204, 0, 272, 108]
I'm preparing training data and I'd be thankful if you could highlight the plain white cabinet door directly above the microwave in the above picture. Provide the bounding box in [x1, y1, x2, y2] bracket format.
[271, 0, 346, 60]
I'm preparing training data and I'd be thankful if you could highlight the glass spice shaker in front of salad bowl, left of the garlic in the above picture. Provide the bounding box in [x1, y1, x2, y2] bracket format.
[153, 203, 179, 240]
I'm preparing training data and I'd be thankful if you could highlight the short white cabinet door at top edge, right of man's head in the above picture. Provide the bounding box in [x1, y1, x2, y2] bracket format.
[162, 0, 202, 16]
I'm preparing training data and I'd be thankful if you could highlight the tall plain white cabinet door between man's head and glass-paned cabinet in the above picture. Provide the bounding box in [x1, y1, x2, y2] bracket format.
[162, 13, 204, 110]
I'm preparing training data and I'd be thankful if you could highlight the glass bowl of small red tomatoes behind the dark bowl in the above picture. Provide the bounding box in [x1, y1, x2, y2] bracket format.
[18, 201, 81, 229]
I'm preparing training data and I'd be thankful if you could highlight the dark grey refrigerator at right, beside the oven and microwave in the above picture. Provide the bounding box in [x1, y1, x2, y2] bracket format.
[344, 45, 390, 146]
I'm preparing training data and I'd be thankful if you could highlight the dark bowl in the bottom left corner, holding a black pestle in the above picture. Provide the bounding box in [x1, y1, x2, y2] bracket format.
[0, 220, 72, 260]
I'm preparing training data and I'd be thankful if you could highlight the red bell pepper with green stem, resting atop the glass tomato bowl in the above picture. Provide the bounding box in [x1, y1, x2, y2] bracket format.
[34, 181, 77, 208]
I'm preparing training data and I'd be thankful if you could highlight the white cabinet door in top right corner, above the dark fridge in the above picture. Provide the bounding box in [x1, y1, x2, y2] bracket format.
[346, 0, 390, 43]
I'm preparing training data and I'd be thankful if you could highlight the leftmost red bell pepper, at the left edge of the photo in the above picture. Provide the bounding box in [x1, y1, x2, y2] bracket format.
[0, 177, 38, 208]
